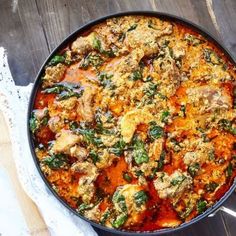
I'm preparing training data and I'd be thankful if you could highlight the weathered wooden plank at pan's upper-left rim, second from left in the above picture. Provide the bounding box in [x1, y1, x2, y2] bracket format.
[37, 0, 108, 51]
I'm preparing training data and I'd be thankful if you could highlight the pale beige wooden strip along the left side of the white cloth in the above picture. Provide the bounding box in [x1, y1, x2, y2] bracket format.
[0, 112, 49, 236]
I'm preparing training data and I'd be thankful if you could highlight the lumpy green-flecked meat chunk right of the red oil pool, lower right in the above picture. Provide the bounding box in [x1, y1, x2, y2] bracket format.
[154, 170, 192, 200]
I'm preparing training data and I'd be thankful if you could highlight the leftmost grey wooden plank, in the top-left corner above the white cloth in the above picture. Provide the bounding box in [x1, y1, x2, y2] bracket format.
[0, 0, 48, 85]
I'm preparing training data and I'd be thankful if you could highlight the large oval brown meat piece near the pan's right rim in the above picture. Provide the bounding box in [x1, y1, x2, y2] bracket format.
[186, 85, 231, 114]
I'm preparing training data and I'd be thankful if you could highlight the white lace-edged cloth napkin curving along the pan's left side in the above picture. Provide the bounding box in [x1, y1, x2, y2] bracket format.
[0, 47, 97, 236]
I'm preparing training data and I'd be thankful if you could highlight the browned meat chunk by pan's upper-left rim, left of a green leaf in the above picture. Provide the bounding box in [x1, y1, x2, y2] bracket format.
[71, 33, 96, 55]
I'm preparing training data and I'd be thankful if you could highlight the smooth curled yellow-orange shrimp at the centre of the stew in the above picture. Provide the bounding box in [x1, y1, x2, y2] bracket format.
[120, 108, 154, 143]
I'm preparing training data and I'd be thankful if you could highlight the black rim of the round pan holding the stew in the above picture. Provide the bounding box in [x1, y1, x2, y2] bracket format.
[27, 11, 236, 236]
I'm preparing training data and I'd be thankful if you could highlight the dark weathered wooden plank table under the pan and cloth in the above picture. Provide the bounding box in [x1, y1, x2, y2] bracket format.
[0, 0, 236, 236]
